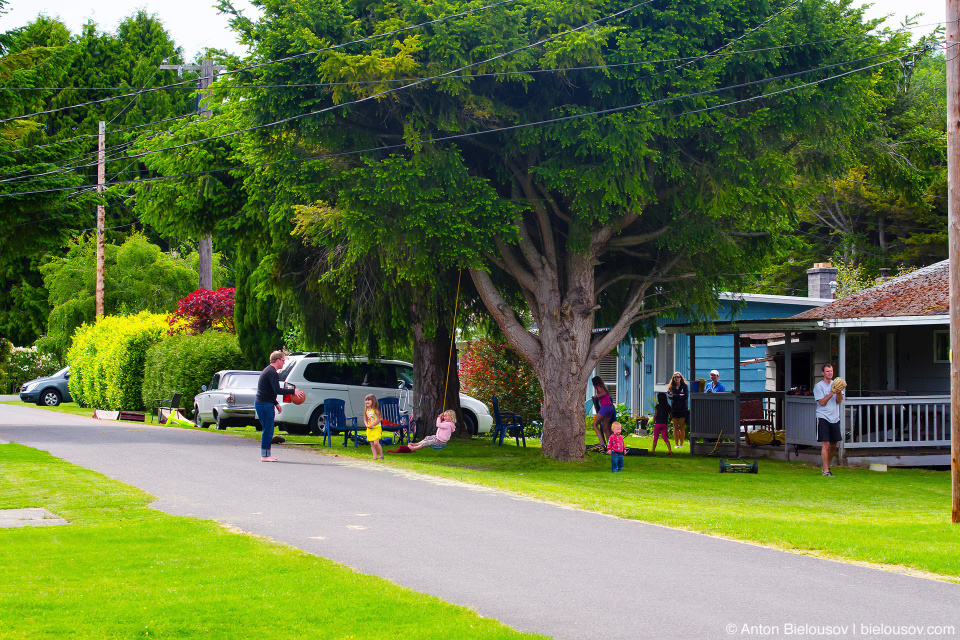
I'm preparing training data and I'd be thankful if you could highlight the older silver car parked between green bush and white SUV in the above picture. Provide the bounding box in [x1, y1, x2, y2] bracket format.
[193, 370, 260, 430]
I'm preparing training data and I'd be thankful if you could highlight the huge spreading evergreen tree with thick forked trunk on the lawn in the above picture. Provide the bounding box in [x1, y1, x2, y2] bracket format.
[222, 0, 902, 460]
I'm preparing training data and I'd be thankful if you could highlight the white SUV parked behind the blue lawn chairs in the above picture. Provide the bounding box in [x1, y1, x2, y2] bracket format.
[277, 353, 493, 434]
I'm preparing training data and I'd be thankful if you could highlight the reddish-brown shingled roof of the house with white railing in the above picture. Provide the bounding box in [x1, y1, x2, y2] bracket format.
[793, 260, 950, 320]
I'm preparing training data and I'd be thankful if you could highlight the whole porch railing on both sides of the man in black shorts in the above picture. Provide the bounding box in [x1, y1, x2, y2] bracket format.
[784, 396, 950, 449]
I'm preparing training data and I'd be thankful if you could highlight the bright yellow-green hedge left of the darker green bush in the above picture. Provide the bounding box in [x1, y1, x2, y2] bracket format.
[67, 311, 167, 411]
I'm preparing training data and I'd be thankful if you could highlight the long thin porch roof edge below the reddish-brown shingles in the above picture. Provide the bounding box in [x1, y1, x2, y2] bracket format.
[661, 314, 950, 336]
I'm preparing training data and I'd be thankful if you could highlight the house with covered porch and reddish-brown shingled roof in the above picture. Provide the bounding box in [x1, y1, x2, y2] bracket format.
[665, 261, 950, 466]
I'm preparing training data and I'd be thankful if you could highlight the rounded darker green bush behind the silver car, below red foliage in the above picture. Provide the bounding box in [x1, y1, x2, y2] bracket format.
[143, 331, 249, 416]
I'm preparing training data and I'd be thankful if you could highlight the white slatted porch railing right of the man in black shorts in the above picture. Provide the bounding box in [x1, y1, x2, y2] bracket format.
[841, 396, 950, 449]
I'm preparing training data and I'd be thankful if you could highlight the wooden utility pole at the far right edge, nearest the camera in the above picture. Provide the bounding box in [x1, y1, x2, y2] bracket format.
[947, 0, 960, 524]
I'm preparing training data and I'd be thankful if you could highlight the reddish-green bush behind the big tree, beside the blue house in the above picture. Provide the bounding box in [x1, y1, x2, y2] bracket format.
[460, 338, 543, 432]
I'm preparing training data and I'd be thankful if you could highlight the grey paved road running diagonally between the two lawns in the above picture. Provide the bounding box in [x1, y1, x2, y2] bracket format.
[0, 406, 960, 640]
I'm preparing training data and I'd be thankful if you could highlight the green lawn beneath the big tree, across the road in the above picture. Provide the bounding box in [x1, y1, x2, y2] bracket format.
[7, 402, 960, 581]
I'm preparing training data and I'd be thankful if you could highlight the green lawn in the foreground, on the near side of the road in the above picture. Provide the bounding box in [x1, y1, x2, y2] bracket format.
[0, 444, 542, 639]
